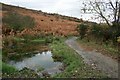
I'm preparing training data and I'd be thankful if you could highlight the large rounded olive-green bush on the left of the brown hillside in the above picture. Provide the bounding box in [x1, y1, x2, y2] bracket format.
[3, 12, 35, 31]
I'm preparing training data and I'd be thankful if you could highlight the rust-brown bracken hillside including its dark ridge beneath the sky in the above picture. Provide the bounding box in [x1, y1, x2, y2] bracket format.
[0, 4, 82, 36]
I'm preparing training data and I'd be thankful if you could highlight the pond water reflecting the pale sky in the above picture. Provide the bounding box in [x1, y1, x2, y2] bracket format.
[10, 51, 62, 74]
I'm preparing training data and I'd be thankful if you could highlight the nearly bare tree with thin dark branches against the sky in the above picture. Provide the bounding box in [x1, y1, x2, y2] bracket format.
[82, 0, 120, 43]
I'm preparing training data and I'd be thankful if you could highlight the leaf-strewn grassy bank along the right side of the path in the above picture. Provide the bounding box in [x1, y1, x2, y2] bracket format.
[77, 38, 119, 60]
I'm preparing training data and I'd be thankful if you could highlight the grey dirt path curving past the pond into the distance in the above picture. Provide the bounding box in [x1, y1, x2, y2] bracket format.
[65, 37, 118, 78]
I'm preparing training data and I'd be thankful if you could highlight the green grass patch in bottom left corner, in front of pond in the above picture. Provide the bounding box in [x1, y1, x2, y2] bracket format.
[2, 63, 38, 78]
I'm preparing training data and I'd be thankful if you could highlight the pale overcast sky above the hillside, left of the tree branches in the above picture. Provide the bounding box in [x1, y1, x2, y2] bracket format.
[0, 0, 97, 20]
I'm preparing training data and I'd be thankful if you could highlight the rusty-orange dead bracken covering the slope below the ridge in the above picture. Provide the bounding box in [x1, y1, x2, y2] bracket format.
[3, 5, 78, 36]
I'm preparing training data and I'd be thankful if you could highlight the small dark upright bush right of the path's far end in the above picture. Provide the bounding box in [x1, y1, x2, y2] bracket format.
[77, 24, 88, 39]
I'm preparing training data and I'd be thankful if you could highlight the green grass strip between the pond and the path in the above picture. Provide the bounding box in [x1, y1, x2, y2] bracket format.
[50, 40, 106, 78]
